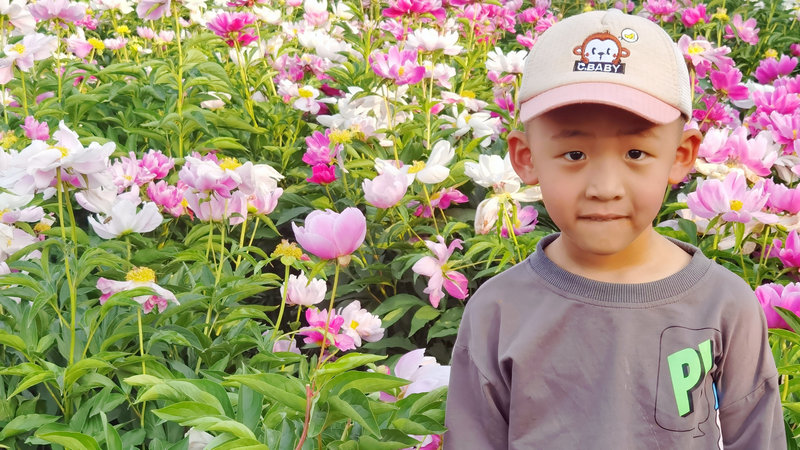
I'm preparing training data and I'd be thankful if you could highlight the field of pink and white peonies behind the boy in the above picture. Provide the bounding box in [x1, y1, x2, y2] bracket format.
[0, 0, 800, 449]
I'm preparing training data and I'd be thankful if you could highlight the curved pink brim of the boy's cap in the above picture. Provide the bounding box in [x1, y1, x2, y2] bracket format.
[519, 83, 681, 123]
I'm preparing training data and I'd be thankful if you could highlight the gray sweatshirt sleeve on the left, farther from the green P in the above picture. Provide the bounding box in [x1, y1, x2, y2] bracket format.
[444, 346, 508, 450]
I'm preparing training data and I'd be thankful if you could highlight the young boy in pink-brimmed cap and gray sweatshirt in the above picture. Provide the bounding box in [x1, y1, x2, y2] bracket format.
[444, 10, 786, 450]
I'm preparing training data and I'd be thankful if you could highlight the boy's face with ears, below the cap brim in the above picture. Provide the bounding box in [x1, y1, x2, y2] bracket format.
[508, 104, 700, 256]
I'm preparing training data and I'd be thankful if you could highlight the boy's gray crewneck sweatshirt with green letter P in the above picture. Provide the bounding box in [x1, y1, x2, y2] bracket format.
[444, 235, 786, 450]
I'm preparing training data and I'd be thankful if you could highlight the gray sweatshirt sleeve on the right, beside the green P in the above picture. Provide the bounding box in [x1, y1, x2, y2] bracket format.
[719, 286, 786, 450]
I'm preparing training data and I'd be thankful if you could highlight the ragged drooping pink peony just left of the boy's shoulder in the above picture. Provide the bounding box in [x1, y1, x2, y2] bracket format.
[411, 236, 469, 308]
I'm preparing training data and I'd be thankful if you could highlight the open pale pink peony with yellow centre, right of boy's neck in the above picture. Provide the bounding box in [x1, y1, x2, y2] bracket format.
[686, 172, 778, 224]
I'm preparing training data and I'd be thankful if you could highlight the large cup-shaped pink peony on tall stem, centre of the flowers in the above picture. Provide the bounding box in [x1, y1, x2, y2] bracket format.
[292, 207, 367, 265]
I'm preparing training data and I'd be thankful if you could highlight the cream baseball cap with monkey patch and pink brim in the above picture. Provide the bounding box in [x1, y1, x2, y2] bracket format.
[519, 9, 692, 123]
